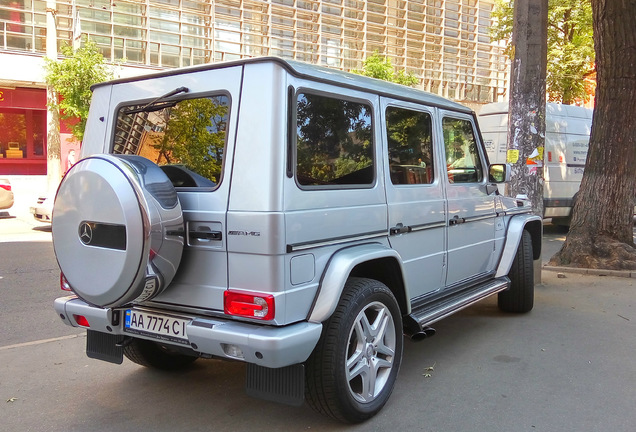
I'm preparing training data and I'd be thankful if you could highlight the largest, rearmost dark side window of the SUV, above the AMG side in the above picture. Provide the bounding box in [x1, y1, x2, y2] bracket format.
[296, 93, 375, 186]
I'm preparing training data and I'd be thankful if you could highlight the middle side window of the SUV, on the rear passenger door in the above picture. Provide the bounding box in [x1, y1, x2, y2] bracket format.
[386, 107, 433, 185]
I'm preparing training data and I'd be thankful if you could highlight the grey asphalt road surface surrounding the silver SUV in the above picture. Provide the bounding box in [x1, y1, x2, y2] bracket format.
[0, 220, 636, 432]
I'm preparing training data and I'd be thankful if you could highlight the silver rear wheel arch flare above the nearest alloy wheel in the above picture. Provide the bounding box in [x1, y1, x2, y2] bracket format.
[309, 243, 410, 322]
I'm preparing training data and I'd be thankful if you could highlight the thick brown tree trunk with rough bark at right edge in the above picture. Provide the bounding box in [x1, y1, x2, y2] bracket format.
[550, 0, 636, 269]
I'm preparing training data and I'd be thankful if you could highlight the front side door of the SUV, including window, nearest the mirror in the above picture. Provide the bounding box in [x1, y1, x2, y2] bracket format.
[441, 111, 496, 287]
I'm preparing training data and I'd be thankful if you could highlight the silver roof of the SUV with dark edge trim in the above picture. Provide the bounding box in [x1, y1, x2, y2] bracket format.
[91, 57, 473, 114]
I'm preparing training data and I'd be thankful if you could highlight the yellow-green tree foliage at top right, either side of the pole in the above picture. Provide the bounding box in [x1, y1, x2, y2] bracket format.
[490, 0, 594, 104]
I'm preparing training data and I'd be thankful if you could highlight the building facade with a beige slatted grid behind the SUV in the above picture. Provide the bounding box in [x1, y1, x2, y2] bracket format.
[0, 0, 508, 103]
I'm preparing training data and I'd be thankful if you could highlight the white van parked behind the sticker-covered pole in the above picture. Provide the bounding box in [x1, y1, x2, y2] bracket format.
[479, 102, 593, 225]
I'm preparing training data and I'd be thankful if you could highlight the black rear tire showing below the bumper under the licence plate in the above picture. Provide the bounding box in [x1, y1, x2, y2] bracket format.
[124, 339, 198, 371]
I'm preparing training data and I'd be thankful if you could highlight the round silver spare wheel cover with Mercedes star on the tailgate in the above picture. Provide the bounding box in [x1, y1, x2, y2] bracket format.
[52, 155, 184, 307]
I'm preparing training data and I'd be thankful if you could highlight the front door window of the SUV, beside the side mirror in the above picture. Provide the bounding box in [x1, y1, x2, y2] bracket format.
[442, 117, 484, 183]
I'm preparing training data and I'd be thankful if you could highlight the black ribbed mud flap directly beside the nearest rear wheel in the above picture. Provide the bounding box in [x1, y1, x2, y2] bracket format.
[245, 363, 305, 406]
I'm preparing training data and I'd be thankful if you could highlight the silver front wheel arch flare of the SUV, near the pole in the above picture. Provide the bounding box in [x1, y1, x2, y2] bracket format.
[495, 214, 543, 277]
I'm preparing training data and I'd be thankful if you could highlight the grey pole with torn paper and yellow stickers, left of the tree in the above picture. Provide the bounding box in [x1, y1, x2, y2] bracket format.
[506, 0, 548, 216]
